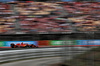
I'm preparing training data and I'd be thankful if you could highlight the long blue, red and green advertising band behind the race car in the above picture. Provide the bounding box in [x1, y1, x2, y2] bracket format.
[0, 40, 100, 48]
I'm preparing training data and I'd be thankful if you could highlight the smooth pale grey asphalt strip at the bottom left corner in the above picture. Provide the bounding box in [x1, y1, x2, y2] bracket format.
[0, 57, 61, 66]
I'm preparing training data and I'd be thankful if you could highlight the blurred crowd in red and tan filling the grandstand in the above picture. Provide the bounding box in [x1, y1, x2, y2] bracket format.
[0, 0, 100, 33]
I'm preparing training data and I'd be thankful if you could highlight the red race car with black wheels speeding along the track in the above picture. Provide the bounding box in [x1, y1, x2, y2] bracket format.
[11, 42, 38, 48]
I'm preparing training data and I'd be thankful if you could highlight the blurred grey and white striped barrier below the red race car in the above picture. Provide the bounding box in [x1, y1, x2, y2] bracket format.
[0, 48, 88, 63]
